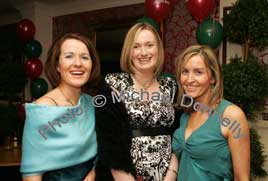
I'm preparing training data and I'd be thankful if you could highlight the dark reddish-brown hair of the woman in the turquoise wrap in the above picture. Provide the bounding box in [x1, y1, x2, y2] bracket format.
[45, 33, 100, 92]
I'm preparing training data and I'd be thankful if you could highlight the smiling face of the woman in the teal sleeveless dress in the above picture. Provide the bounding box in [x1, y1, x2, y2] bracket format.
[180, 55, 215, 103]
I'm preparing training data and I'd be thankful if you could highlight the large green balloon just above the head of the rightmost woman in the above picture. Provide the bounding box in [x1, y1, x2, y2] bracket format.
[196, 18, 223, 48]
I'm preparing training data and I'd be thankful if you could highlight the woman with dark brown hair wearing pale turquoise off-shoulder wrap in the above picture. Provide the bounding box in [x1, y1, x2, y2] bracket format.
[21, 33, 100, 181]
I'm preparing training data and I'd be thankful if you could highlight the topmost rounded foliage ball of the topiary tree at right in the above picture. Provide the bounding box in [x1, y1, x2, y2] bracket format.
[223, 0, 268, 61]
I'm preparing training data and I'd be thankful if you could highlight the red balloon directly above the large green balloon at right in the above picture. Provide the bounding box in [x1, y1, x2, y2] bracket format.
[186, 0, 215, 22]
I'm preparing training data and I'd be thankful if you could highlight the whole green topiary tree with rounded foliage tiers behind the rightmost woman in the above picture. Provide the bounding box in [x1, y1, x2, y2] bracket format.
[223, 0, 268, 178]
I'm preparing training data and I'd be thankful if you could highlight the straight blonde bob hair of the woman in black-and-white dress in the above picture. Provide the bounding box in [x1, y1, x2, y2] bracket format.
[120, 23, 164, 76]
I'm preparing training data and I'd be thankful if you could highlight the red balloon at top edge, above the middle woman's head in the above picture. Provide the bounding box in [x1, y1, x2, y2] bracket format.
[145, 0, 171, 22]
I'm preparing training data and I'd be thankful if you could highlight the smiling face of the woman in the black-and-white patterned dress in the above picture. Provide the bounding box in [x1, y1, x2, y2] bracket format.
[131, 29, 158, 73]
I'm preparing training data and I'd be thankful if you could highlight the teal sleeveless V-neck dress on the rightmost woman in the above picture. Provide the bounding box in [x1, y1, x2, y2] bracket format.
[172, 99, 233, 181]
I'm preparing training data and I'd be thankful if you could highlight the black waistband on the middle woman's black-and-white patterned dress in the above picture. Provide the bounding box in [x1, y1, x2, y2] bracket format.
[132, 128, 170, 138]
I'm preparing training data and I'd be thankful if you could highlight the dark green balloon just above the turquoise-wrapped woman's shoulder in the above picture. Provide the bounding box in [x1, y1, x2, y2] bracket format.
[30, 78, 48, 98]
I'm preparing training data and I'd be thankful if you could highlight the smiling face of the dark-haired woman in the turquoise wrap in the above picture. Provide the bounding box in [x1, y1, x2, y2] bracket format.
[57, 39, 92, 88]
